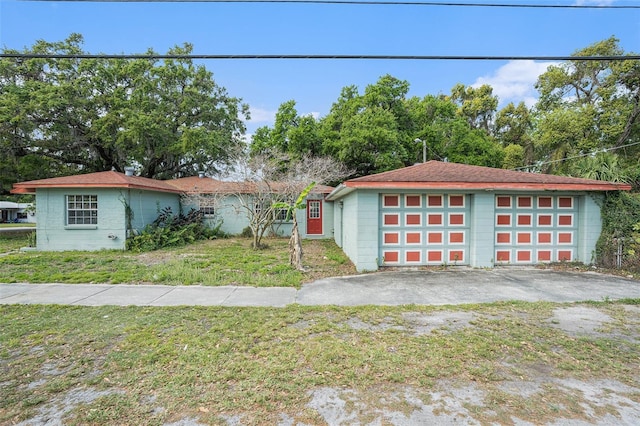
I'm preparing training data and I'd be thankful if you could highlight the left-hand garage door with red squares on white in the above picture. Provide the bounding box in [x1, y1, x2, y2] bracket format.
[379, 194, 469, 266]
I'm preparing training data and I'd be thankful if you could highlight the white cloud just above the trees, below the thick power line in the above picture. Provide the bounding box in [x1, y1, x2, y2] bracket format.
[471, 61, 558, 107]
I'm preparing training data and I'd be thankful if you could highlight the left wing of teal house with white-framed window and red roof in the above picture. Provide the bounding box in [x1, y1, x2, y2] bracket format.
[12, 171, 181, 250]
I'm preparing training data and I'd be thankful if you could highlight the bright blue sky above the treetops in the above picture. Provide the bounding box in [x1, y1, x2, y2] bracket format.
[0, 0, 640, 133]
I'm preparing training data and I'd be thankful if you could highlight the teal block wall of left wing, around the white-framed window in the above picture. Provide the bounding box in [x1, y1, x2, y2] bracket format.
[36, 188, 180, 251]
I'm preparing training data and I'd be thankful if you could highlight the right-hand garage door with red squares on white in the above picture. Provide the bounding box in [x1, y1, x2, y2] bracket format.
[495, 195, 578, 264]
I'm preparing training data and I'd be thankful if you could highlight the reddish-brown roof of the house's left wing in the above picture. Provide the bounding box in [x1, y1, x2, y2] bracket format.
[11, 171, 182, 194]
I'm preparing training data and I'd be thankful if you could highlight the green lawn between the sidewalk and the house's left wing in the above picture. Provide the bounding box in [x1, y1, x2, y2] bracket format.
[0, 235, 355, 287]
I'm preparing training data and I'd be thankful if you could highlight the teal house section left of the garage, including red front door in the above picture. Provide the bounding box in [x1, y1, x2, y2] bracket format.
[12, 171, 333, 250]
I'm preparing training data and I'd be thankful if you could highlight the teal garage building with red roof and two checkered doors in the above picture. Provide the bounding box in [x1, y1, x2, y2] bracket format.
[327, 161, 631, 271]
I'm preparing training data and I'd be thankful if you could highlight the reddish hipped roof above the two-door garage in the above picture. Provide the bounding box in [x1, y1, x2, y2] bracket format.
[334, 161, 631, 195]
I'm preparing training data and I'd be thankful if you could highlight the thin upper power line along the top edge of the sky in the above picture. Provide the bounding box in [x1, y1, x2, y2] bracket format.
[27, 0, 640, 9]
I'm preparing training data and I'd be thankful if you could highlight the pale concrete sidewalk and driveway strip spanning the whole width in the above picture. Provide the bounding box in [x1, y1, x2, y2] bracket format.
[0, 268, 640, 307]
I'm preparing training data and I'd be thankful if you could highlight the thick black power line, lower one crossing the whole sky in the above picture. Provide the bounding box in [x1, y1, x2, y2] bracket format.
[0, 51, 640, 62]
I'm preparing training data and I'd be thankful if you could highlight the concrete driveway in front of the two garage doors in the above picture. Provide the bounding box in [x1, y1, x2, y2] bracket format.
[297, 268, 640, 305]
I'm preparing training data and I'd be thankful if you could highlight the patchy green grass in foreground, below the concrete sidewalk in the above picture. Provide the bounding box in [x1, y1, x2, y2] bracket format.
[0, 301, 640, 425]
